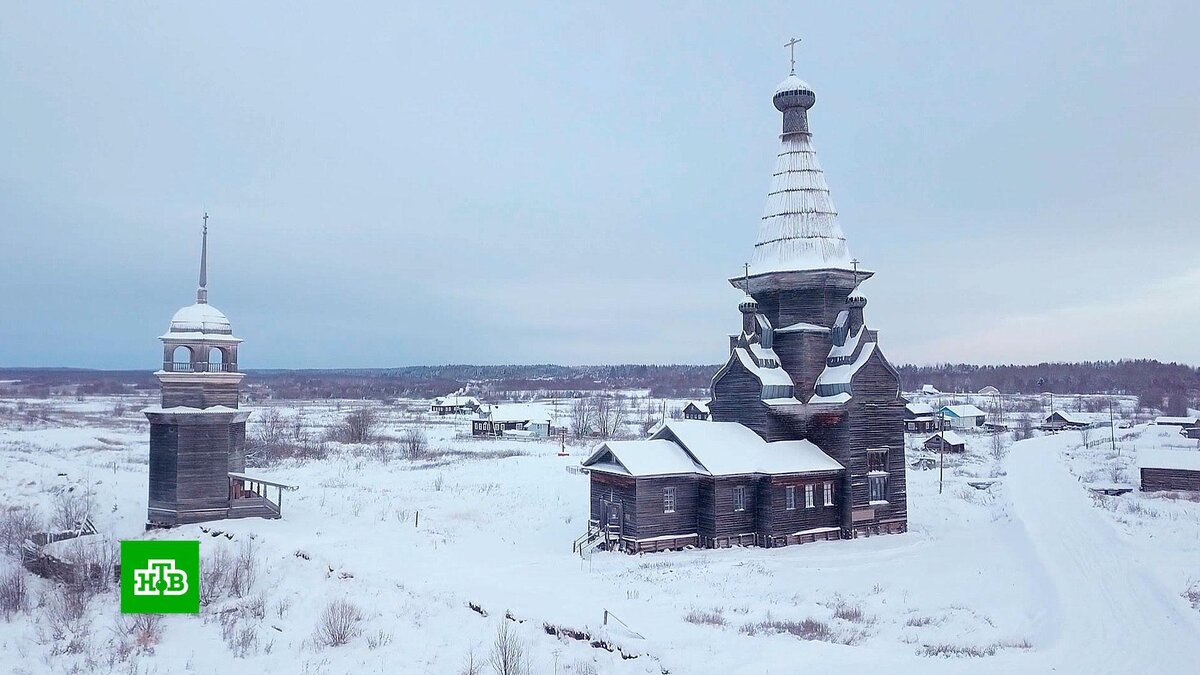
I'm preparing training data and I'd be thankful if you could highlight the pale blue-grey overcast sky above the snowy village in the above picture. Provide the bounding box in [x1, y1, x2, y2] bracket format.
[0, 1, 1200, 369]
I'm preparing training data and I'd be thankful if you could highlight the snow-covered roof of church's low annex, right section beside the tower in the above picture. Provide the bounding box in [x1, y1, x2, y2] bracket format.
[653, 419, 842, 476]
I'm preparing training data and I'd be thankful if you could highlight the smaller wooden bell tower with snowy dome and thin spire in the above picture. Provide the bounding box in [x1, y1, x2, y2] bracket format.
[143, 214, 294, 527]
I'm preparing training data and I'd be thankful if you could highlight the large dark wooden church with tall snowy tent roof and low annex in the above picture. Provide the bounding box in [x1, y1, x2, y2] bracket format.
[577, 61, 907, 552]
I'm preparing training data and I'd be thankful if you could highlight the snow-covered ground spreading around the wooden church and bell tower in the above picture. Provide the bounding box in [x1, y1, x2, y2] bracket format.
[0, 398, 1200, 675]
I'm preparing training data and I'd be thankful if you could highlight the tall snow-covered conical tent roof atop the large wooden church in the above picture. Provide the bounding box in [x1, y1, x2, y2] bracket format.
[750, 127, 852, 274]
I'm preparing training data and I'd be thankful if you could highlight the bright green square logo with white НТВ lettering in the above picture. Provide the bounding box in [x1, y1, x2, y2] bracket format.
[121, 540, 200, 614]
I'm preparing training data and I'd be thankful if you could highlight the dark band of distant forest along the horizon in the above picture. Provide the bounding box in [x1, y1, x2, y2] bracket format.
[0, 360, 1200, 412]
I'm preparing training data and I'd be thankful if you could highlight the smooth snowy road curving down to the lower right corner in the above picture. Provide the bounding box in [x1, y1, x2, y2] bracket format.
[1006, 436, 1200, 673]
